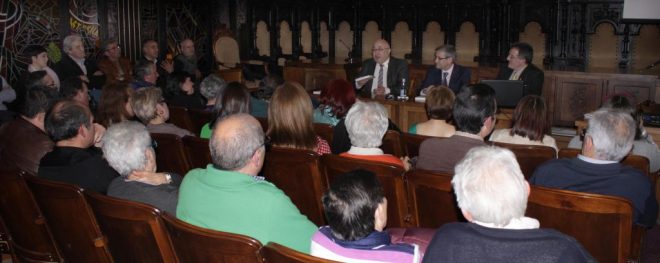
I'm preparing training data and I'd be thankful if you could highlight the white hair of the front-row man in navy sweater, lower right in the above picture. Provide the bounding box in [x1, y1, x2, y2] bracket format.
[451, 146, 528, 226]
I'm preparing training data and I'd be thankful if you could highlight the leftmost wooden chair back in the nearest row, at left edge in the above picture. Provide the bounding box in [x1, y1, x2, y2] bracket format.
[0, 168, 62, 262]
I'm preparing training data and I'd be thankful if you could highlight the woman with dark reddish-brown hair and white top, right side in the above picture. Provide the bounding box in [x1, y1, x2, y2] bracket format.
[490, 95, 558, 152]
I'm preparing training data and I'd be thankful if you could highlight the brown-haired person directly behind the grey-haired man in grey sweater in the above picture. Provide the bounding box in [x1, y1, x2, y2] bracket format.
[97, 82, 135, 128]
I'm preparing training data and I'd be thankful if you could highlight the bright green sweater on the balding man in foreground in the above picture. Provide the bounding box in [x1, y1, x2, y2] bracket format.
[176, 164, 317, 253]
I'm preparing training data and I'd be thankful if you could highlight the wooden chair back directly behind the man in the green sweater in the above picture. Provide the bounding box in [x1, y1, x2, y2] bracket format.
[163, 213, 262, 263]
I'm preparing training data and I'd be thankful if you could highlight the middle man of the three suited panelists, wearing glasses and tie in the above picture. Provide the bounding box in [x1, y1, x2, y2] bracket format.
[416, 45, 471, 95]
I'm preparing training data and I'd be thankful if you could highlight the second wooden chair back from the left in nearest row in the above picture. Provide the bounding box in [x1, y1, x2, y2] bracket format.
[25, 176, 112, 262]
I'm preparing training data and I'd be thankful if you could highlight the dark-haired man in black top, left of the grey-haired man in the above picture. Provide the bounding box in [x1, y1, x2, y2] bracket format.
[38, 101, 118, 193]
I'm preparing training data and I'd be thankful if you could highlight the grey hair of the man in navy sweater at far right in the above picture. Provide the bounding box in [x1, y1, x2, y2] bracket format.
[586, 108, 636, 162]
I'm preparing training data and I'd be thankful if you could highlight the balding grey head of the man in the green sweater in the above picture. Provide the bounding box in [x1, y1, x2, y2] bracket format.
[209, 114, 264, 171]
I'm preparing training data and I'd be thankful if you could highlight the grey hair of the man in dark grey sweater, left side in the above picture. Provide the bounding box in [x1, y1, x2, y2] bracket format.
[102, 121, 153, 176]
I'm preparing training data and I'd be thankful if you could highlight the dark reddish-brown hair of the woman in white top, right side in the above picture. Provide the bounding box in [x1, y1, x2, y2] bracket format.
[510, 95, 550, 141]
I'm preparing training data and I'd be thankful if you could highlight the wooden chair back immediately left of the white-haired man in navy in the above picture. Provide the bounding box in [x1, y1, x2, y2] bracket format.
[406, 170, 466, 228]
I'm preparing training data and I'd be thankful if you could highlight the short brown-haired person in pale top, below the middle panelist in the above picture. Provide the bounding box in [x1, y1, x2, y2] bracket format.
[408, 86, 456, 137]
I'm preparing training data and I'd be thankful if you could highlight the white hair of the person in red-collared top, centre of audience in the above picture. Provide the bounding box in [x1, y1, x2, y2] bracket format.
[345, 101, 388, 148]
